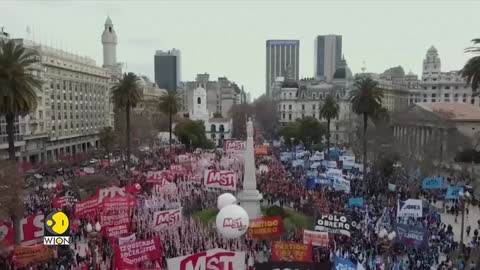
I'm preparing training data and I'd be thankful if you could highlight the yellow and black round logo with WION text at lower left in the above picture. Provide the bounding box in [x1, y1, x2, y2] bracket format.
[43, 211, 70, 246]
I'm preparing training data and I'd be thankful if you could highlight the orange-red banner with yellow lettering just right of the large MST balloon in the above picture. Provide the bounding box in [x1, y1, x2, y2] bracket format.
[248, 217, 283, 239]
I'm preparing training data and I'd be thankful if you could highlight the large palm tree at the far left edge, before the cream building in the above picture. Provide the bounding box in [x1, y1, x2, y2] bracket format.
[0, 40, 42, 161]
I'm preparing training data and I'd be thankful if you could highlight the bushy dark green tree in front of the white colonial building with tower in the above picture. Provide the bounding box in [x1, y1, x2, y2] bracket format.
[174, 119, 215, 148]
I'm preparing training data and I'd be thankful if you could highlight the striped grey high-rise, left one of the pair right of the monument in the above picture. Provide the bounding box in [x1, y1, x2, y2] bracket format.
[265, 40, 300, 97]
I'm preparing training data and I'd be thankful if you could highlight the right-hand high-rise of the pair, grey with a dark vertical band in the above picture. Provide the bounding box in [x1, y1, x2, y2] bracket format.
[314, 35, 342, 82]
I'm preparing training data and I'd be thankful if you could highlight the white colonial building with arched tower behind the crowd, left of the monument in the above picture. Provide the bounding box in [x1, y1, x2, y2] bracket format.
[189, 87, 232, 145]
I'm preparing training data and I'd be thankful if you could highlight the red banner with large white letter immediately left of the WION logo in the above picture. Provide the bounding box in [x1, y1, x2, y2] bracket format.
[20, 214, 44, 246]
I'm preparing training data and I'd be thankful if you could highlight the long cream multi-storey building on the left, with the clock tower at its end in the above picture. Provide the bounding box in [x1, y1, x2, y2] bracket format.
[0, 18, 121, 163]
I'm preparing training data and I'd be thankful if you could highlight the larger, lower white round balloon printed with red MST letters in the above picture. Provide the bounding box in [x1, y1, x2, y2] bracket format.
[215, 204, 250, 238]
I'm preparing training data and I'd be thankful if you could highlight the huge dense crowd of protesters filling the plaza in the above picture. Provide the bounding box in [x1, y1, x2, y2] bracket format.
[6, 141, 480, 270]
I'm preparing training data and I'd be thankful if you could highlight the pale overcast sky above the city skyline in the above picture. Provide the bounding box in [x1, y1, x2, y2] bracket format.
[0, 0, 480, 97]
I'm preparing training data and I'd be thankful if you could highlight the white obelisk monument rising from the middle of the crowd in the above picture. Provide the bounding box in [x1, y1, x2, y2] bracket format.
[238, 118, 263, 219]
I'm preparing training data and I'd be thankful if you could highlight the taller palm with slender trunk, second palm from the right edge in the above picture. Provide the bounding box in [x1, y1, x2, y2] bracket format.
[350, 75, 383, 185]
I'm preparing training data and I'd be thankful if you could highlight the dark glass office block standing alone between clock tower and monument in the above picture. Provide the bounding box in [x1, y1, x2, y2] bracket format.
[154, 49, 180, 91]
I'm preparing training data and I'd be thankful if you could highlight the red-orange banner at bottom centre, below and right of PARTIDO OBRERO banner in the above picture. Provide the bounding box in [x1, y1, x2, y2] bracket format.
[272, 242, 312, 262]
